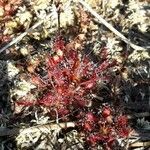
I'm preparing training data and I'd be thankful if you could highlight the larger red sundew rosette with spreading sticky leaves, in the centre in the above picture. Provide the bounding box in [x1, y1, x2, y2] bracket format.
[20, 38, 116, 112]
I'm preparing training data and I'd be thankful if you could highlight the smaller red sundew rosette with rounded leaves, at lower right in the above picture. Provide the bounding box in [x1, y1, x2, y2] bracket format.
[79, 106, 130, 150]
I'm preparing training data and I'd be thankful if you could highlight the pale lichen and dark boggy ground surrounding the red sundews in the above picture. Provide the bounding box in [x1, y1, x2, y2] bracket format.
[0, 0, 150, 150]
